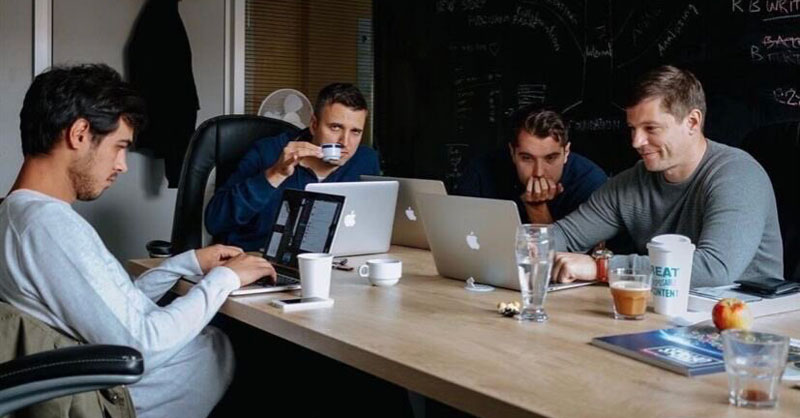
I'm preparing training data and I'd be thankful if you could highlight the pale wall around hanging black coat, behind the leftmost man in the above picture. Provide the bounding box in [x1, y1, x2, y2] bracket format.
[0, 0, 224, 260]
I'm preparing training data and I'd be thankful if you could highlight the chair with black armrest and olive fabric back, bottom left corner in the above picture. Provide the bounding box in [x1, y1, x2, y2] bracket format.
[0, 301, 144, 417]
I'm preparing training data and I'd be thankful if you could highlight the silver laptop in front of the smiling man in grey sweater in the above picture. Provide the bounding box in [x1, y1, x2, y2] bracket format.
[417, 194, 594, 291]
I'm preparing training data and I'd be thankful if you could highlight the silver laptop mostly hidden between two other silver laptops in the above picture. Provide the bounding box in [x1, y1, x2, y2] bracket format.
[361, 176, 447, 250]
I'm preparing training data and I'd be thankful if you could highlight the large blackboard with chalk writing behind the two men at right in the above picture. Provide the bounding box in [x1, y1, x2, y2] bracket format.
[373, 0, 800, 185]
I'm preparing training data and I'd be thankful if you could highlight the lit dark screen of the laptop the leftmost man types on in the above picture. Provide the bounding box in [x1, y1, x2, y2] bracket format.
[264, 189, 345, 270]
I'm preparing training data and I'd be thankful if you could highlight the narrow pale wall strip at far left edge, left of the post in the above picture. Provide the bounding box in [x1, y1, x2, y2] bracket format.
[0, 1, 33, 197]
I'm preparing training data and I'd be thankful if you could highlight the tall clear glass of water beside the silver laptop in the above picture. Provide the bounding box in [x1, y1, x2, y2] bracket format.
[516, 224, 556, 322]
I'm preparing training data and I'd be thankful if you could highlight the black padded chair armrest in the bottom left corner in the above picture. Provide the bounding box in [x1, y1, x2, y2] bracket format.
[0, 345, 144, 416]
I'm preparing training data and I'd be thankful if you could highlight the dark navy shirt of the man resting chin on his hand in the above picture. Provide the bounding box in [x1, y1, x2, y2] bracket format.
[454, 149, 608, 223]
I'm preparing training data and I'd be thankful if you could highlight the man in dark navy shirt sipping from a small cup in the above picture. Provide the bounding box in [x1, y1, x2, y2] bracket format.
[205, 83, 380, 251]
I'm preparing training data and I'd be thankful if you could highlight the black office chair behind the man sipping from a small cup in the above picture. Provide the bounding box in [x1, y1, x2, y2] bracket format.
[148, 115, 300, 255]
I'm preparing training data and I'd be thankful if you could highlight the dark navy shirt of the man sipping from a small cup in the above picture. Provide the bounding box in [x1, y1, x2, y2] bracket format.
[205, 133, 380, 251]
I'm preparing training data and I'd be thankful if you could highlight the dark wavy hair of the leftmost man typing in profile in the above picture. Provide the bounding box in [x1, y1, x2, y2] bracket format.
[19, 64, 146, 156]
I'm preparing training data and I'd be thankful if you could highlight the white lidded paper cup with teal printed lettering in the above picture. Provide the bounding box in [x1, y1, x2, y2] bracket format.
[647, 234, 695, 316]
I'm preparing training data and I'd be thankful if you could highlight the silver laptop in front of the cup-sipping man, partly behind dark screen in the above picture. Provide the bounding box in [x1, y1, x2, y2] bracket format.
[306, 181, 399, 256]
